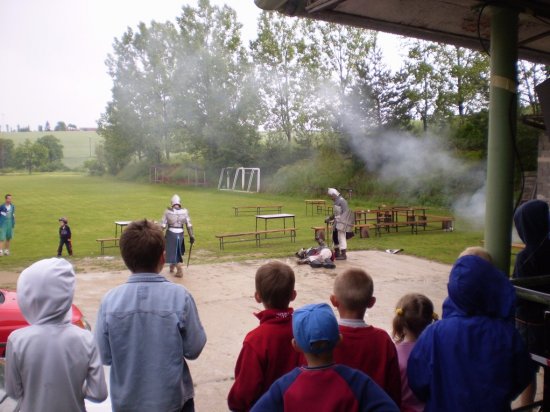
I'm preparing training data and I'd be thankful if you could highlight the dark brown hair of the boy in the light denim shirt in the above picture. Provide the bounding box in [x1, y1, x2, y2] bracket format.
[120, 219, 165, 273]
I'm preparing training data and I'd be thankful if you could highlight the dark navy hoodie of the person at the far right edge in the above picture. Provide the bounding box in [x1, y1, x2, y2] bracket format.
[513, 200, 550, 323]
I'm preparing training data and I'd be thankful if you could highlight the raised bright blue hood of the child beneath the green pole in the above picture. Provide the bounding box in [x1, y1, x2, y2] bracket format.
[443, 255, 516, 320]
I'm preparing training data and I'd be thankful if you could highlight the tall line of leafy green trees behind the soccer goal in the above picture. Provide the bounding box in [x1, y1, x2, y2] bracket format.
[95, 0, 548, 198]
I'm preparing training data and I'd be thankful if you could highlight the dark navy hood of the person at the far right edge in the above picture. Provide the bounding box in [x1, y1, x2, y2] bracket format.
[514, 200, 550, 248]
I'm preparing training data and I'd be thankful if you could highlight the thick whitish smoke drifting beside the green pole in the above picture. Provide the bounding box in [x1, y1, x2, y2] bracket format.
[343, 106, 485, 229]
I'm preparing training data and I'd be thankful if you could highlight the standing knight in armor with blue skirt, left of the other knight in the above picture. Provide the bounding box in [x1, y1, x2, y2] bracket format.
[162, 195, 195, 278]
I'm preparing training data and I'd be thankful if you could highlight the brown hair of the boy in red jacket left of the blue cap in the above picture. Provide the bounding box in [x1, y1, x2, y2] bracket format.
[256, 261, 295, 309]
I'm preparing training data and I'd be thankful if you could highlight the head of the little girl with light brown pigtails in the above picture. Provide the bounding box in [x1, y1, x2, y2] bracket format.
[392, 293, 437, 342]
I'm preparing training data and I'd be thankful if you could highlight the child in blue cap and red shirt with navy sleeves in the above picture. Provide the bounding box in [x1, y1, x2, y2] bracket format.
[252, 303, 399, 412]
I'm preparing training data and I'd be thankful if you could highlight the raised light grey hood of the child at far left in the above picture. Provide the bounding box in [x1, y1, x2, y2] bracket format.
[17, 258, 75, 325]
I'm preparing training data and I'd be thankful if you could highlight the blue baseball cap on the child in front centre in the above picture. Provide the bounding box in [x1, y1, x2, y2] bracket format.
[292, 303, 340, 354]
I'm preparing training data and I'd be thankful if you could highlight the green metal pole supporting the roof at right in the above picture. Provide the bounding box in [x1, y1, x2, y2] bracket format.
[485, 7, 518, 273]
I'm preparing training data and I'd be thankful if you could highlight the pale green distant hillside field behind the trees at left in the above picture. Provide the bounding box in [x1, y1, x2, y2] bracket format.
[0, 132, 101, 169]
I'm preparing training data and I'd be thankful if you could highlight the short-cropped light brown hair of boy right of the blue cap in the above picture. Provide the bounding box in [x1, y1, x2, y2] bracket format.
[334, 268, 374, 311]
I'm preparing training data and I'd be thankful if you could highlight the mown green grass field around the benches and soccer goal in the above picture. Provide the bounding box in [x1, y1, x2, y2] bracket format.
[0, 174, 483, 270]
